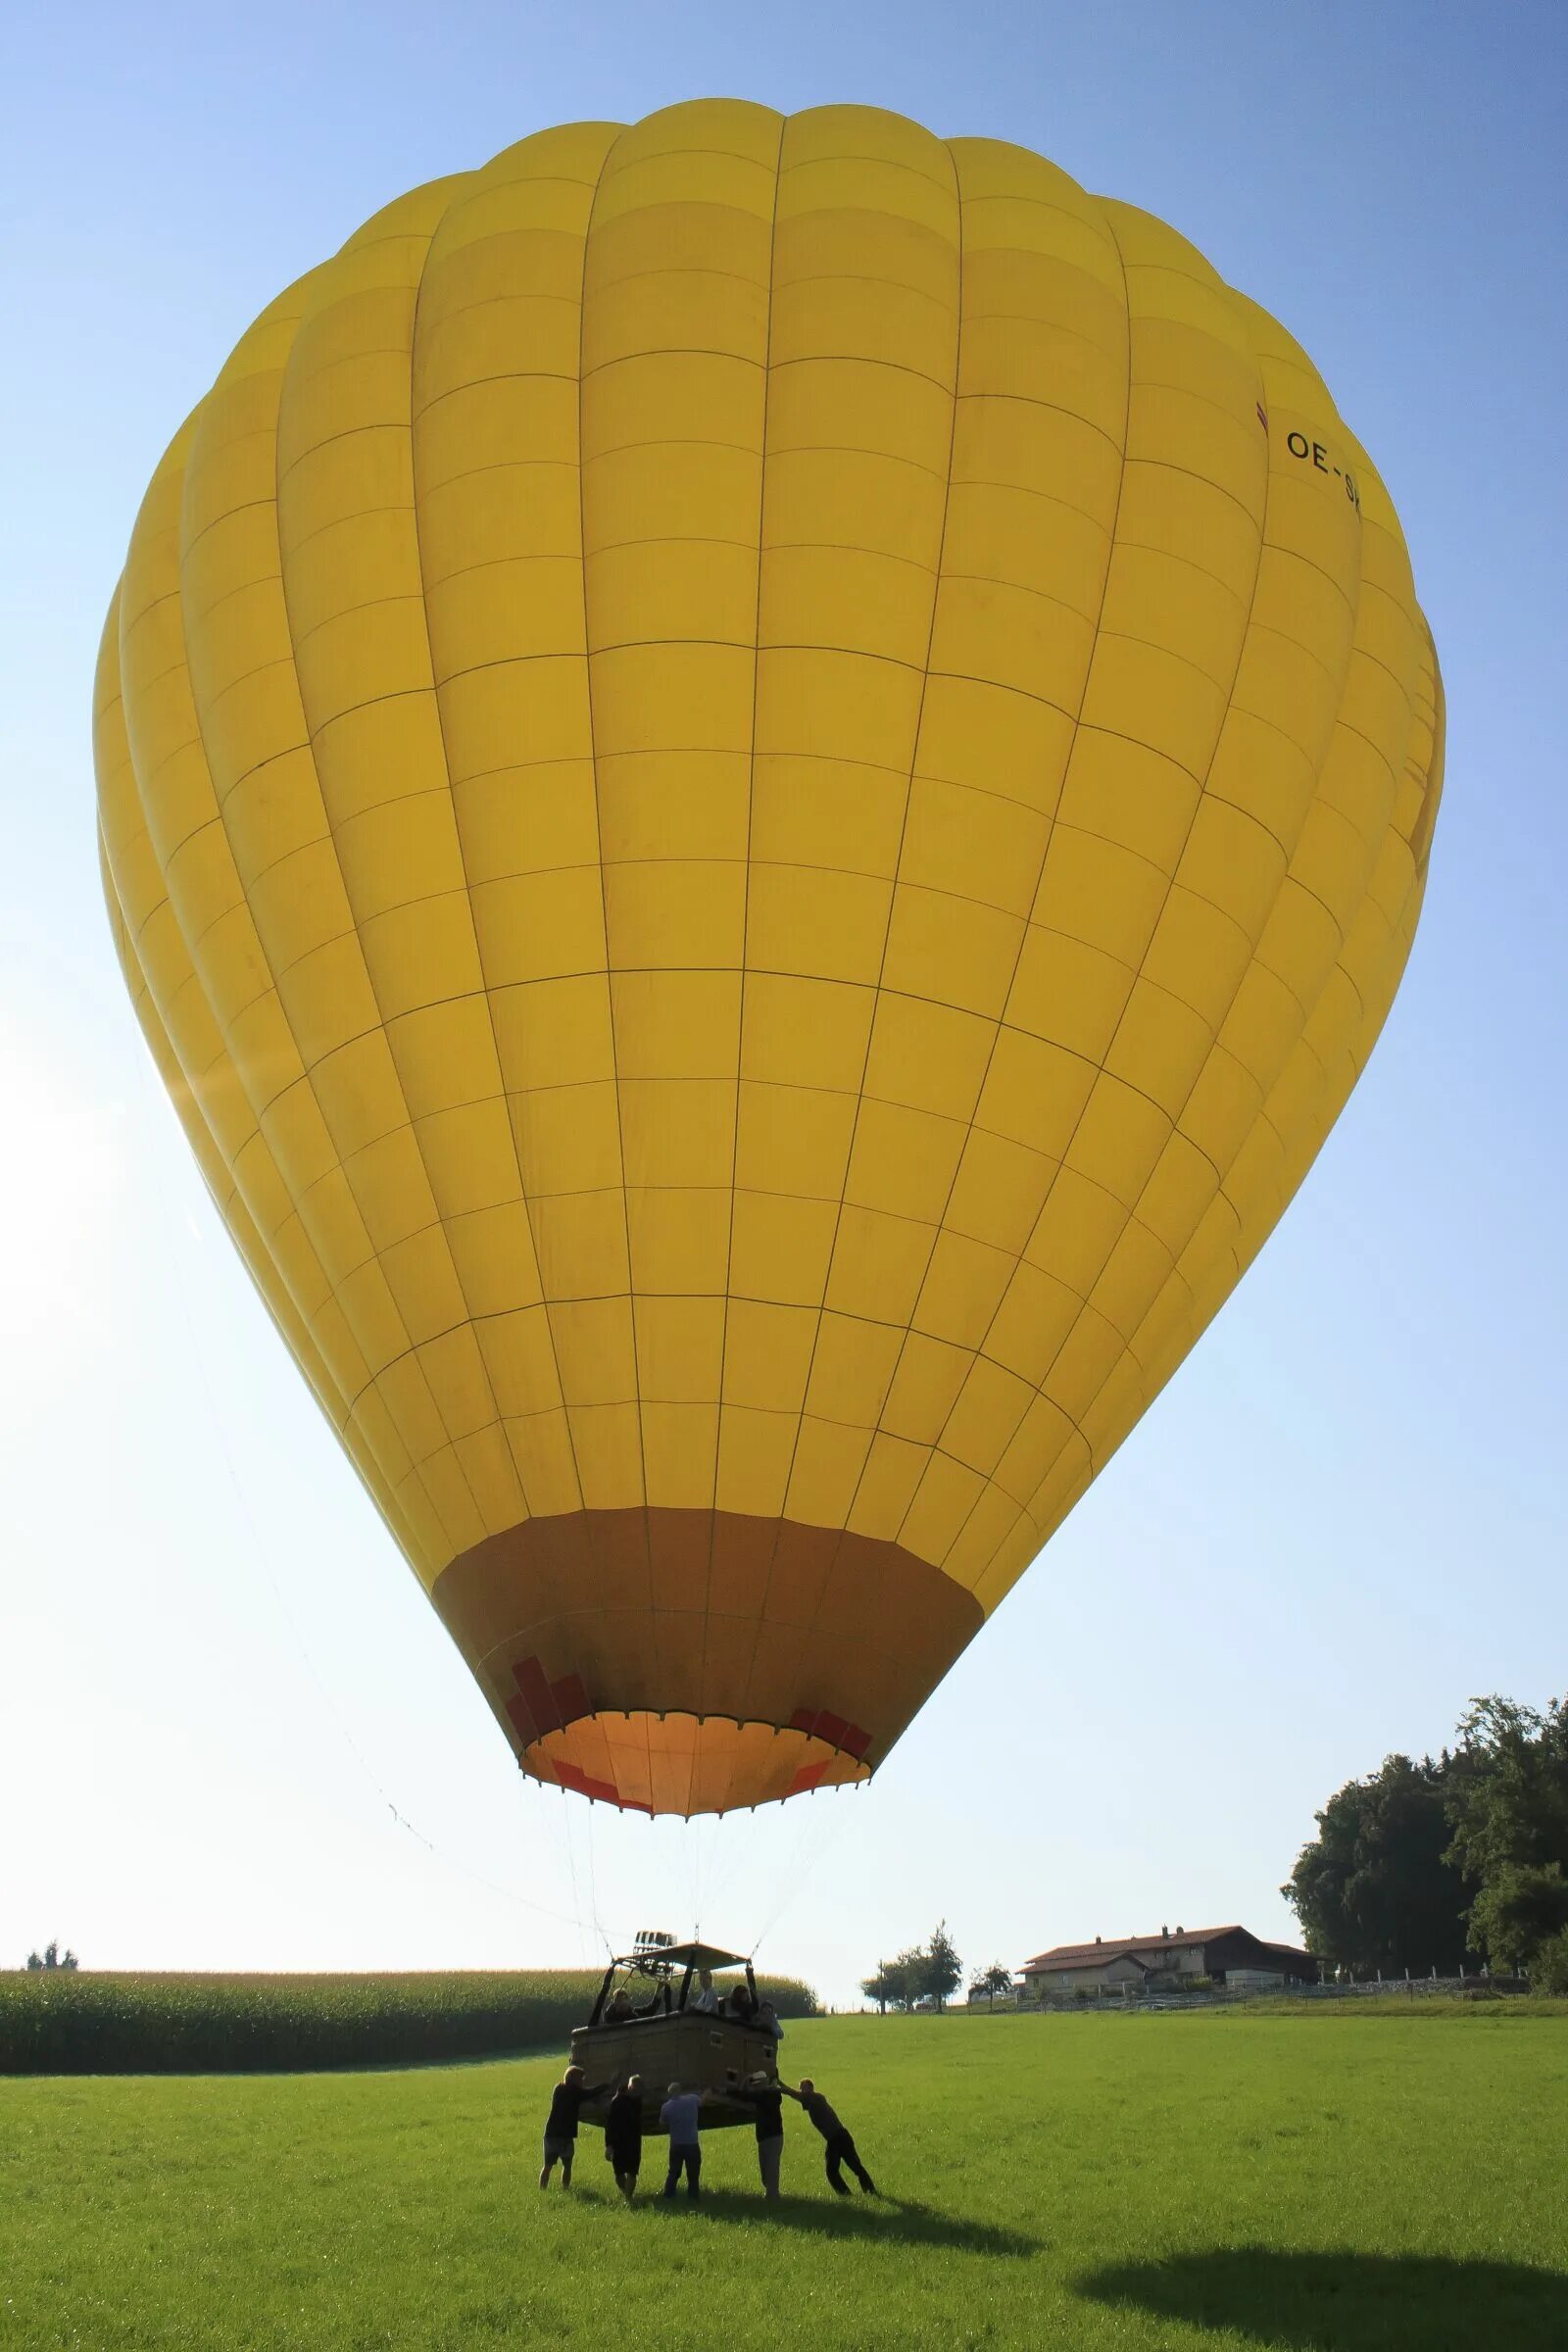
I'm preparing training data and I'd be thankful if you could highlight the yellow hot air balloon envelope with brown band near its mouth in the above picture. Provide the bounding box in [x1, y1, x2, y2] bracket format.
[96, 101, 1441, 1813]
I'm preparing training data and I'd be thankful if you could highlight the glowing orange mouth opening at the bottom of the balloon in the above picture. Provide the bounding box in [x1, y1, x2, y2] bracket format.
[519, 1710, 872, 1818]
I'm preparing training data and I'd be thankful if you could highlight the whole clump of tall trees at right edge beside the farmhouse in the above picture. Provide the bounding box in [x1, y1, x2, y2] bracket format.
[1281, 1695, 1568, 1992]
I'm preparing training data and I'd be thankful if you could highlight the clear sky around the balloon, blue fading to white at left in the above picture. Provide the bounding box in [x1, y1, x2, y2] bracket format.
[0, 0, 1568, 2001]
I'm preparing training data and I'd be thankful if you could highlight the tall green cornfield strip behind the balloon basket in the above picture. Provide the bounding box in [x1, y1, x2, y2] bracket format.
[0, 1969, 818, 2075]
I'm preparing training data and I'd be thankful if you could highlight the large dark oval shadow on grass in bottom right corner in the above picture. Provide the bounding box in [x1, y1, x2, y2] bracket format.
[1074, 2246, 1568, 2352]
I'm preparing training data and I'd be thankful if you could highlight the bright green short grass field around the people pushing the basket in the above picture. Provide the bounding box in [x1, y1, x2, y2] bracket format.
[0, 2006, 1568, 2352]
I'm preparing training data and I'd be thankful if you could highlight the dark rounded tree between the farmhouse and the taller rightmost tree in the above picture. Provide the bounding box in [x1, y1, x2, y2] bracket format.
[1281, 1754, 1474, 1976]
